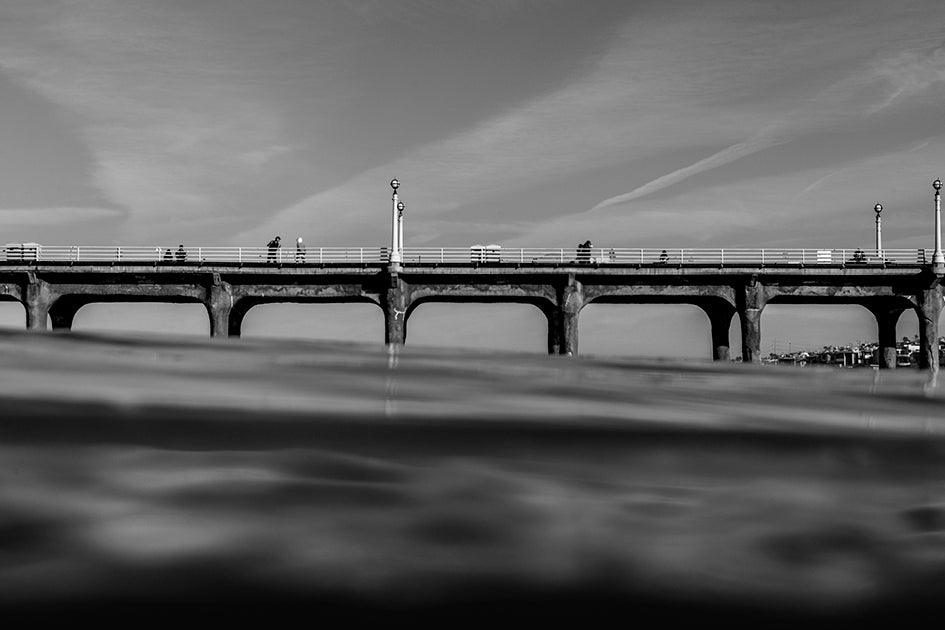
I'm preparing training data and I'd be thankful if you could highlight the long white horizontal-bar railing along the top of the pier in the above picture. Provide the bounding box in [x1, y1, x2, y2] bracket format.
[0, 243, 932, 267]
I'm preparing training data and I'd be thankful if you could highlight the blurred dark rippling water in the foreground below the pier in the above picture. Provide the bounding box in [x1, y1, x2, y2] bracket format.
[0, 331, 945, 626]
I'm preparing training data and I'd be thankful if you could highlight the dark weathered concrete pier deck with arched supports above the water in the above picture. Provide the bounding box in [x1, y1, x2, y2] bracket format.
[0, 261, 943, 370]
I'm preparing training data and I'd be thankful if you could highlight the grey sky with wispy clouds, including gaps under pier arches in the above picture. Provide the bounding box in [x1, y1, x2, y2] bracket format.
[0, 0, 945, 356]
